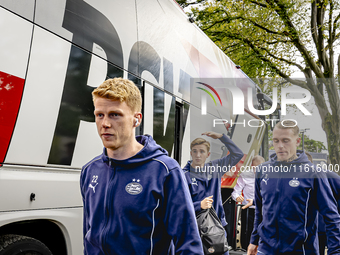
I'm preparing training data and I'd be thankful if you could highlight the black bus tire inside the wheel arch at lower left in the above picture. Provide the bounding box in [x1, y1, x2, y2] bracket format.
[0, 235, 52, 255]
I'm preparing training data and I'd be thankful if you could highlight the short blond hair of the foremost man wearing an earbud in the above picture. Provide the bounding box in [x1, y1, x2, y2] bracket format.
[92, 78, 142, 112]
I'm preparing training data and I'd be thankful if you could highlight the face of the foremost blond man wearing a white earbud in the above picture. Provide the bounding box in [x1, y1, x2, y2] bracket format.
[94, 97, 138, 151]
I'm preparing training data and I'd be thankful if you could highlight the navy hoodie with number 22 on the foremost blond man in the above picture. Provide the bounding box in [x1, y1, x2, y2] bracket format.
[80, 136, 203, 255]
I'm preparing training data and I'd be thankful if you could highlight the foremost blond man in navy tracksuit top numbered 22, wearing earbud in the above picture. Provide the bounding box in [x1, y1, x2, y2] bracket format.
[80, 78, 203, 255]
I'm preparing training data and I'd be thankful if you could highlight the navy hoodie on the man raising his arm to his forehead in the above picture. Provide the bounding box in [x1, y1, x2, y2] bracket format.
[183, 134, 243, 226]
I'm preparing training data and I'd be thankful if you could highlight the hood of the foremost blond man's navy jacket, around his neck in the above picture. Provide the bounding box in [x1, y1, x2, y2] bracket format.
[102, 135, 168, 167]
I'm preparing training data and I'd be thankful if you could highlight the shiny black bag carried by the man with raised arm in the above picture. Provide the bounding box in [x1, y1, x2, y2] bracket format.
[196, 207, 228, 254]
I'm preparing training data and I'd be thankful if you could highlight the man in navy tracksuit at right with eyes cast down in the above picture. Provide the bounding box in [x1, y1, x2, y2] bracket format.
[248, 120, 340, 254]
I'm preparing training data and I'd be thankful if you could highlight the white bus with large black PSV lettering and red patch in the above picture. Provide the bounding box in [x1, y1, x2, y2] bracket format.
[0, 0, 270, 255]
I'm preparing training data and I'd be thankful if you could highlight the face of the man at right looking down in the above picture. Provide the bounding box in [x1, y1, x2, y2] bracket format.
[273, 128, 301, 161]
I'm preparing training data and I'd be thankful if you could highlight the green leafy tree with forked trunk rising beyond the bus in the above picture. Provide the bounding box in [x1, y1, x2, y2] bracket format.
[179, 0, 340, 164]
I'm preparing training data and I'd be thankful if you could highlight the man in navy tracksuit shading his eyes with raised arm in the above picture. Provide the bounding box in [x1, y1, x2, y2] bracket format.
[183, 132, 243, 254]
